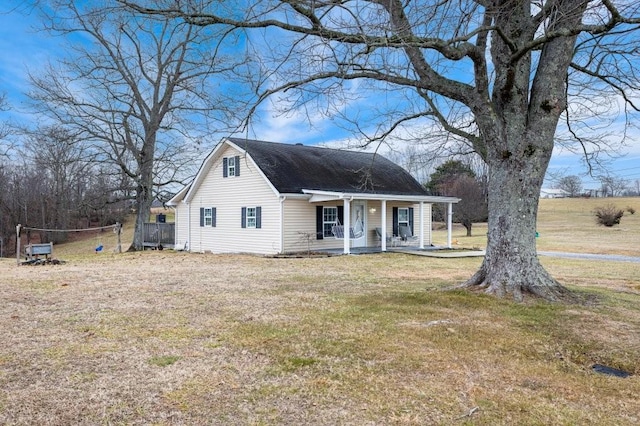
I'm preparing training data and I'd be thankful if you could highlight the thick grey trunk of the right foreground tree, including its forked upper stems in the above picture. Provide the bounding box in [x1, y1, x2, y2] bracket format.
[458, 0, 587, 301]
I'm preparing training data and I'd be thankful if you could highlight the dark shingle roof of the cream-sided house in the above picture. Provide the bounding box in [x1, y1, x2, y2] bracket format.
[228, 138, 428, 195]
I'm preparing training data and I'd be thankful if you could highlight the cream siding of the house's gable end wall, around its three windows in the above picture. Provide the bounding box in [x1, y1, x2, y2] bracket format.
[189, 147, 280, 254]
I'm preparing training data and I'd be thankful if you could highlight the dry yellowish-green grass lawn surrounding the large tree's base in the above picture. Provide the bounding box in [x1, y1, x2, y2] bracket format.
[0, 199, 640, 425]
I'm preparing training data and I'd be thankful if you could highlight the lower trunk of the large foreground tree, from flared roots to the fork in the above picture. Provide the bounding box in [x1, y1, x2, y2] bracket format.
[464, 146, 574, 301]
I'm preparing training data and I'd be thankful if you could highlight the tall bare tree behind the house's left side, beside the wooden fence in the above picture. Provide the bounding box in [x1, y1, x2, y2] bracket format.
[30, 0, 248, 250]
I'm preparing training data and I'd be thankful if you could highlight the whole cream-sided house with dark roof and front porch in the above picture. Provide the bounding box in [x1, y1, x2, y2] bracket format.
[169, 138, 459, 254]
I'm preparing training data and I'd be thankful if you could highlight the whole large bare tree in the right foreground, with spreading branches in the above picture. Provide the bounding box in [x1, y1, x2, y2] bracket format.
[119, 0, 640, 300]
